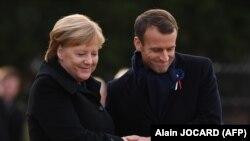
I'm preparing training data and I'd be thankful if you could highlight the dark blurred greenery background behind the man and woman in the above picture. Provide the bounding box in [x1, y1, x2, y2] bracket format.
[0, 0, 250, 140]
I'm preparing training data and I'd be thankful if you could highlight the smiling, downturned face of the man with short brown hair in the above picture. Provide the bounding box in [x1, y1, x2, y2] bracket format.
[134, 26, 177, 73]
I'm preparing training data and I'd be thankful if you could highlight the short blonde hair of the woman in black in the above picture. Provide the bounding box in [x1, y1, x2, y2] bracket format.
[44, 14, 105, 62]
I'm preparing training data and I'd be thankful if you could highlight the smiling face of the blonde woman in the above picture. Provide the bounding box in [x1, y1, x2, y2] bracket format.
[57, 40, 100, 81]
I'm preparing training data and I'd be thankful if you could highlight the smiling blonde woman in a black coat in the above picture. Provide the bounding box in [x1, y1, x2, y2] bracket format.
[27, 14, 138, 141]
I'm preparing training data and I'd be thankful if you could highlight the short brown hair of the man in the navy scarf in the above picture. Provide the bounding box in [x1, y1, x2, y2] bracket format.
[134, 9, 178, 43]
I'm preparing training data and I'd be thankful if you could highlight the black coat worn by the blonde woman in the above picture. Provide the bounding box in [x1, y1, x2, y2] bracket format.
[27, 61, 122, 141]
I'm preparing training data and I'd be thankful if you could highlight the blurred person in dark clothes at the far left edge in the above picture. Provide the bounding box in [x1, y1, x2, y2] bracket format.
[0, 66, 25, 141]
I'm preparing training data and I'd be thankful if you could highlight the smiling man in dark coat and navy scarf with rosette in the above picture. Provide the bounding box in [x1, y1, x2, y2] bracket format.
[106, 9, 222, 136]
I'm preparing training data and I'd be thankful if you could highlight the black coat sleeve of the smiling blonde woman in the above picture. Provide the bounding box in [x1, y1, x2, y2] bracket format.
[29, 77, 122, 141]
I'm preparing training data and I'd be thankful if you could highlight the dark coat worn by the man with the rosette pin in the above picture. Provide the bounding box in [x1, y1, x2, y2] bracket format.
[106, 53, 222, 136]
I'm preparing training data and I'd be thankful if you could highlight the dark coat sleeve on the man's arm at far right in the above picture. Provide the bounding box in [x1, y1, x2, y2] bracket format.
[191, 59, 222, 124]
